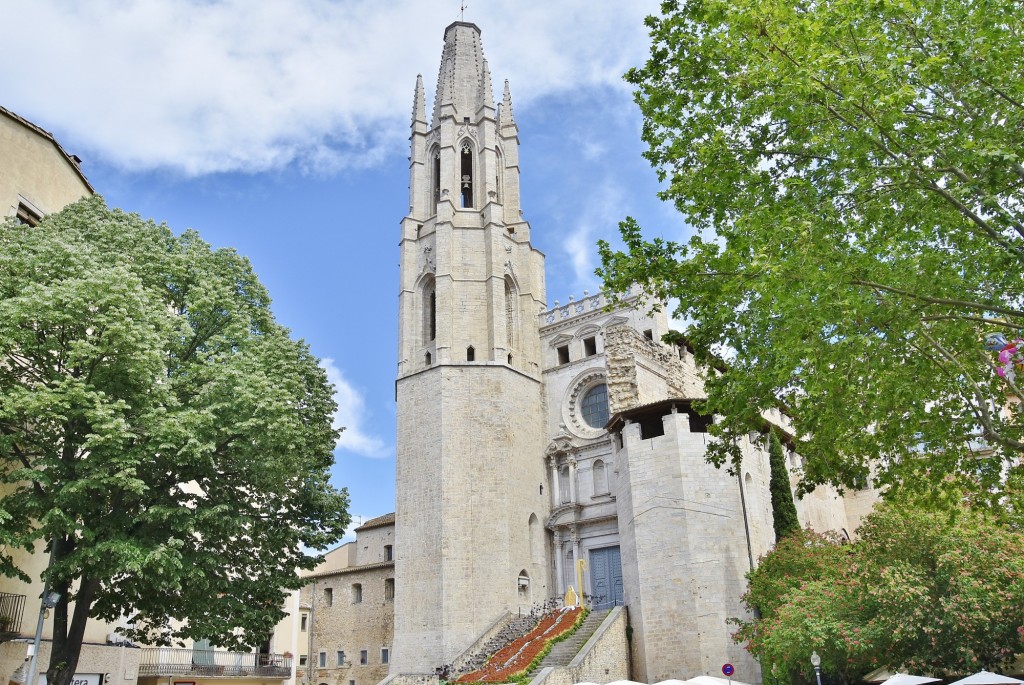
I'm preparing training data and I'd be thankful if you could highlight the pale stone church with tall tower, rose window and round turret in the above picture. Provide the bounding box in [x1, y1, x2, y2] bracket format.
[364, 22, 876, 685]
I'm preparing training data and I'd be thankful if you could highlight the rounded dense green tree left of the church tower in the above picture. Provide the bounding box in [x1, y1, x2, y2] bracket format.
[0, 198, 349, 685]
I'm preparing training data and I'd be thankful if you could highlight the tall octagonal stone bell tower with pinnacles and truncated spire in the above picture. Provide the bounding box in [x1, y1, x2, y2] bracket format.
[391, 22, 550, 674]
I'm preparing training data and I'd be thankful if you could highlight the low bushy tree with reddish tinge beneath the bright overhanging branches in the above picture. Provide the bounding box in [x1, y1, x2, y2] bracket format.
[735, 503, 1024, 683]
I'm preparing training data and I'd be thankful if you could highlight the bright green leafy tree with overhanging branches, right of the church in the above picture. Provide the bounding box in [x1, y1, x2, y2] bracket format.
[600, 0, 1024, 487]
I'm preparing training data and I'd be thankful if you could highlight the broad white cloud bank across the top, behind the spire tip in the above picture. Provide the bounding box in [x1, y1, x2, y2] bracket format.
[0, 0, 657, 175]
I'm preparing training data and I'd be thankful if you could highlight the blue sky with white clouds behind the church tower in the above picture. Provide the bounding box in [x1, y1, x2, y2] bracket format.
[0, 0, 685, 532]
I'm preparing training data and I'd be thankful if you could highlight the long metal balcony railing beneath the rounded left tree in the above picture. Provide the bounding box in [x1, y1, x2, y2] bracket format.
[138, 647, 292, 679]
